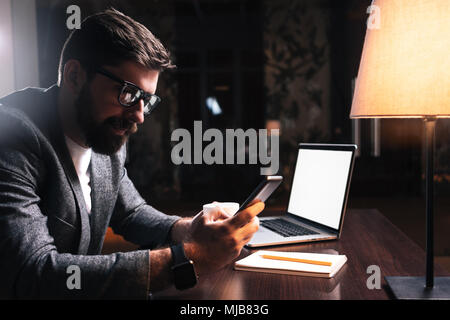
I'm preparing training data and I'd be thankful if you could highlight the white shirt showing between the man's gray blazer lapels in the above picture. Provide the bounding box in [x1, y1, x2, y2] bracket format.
[65, 136, 92, 213]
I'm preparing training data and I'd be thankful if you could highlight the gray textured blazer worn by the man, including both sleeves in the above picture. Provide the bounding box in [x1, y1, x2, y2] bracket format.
[0, 86, 179, 299]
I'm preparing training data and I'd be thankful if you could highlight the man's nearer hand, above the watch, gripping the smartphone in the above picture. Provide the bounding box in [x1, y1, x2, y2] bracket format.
[184, 202, 264, 275]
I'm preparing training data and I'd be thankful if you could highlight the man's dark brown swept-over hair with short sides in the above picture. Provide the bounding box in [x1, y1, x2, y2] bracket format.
[58, 9, 175, 84]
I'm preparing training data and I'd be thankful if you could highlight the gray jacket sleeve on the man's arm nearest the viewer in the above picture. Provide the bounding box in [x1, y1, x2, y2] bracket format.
[0, 105, 150, 299]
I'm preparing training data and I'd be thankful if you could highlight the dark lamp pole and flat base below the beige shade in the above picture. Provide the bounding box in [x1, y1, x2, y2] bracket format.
[386, 117, 450, 300]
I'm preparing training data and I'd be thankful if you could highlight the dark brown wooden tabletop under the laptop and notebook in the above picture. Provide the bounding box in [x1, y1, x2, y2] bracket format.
[153, 209, 448, 300]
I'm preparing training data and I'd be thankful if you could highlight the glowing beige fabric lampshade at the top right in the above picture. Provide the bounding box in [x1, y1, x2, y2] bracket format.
[350, 0, 450, 118]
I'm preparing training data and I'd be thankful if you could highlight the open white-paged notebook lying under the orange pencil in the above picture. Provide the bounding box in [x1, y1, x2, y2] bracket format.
[234, 250, 347, 278]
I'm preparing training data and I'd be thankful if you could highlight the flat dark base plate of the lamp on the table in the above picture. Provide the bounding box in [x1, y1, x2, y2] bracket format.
[385, 277, 450, 300]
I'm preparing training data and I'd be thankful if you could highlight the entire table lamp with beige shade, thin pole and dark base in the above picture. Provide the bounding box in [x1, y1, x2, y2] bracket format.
[350, 0, 450, 299]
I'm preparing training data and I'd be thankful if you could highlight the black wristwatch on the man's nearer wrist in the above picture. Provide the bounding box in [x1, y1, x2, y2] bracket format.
[170, 243, 197, 290]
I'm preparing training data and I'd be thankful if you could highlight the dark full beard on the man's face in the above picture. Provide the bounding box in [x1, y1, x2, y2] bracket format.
[75, 83, 137, 155]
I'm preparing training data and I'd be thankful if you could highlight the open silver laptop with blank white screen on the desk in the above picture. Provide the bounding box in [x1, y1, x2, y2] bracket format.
[247, 143, 357, 247]
